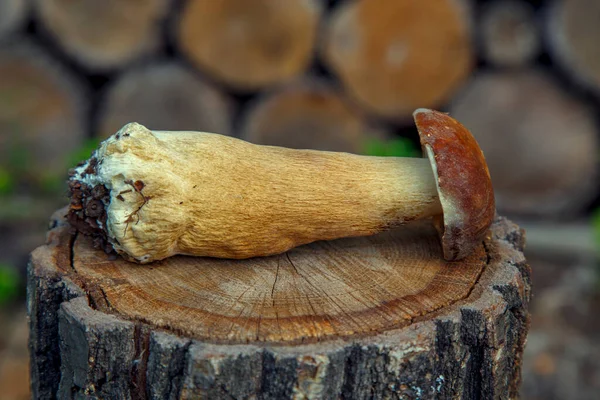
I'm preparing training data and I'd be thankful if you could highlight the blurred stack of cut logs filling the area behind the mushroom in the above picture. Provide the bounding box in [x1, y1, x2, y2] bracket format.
[0, 0, 600, 216]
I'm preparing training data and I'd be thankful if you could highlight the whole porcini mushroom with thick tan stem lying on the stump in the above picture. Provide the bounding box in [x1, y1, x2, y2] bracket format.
[68, 109, 495, 263]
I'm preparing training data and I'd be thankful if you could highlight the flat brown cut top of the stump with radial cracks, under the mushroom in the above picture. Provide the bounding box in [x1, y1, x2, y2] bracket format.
[74, 220, 486, 343]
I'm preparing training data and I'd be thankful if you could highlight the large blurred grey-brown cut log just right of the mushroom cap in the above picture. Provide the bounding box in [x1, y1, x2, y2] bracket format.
[450, 70, 599, 217]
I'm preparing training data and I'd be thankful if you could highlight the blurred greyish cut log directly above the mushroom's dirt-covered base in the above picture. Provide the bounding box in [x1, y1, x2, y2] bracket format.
[98, 62, 233, 139]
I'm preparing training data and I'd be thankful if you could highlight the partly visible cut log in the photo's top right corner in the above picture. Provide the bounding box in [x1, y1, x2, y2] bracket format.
[546, 0, 600, 92]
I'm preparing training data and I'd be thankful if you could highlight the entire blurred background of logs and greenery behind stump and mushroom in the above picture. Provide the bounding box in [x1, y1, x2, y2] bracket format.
[0, 0, 600, 399]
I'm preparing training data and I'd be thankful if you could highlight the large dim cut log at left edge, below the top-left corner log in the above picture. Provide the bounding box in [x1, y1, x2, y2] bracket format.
[0, 38, 88, 181]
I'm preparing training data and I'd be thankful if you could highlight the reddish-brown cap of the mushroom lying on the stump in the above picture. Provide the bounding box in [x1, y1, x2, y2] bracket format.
[413, 108, 496, 261]
